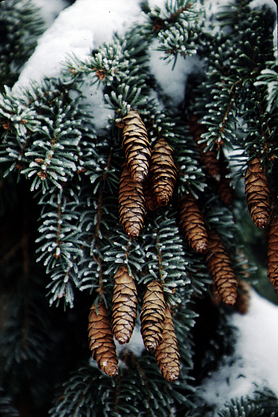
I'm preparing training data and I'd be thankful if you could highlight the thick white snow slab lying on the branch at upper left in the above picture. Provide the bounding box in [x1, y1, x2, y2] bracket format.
[13, 0, 146, 91]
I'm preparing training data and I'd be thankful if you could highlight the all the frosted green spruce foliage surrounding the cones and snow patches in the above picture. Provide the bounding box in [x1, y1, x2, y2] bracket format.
[0, 0, 278, 417]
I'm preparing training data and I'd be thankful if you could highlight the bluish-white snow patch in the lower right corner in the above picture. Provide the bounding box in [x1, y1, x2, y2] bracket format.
[201, 290, 278, 410]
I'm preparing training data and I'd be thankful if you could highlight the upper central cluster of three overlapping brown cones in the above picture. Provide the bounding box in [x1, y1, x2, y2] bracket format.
[119, 110, 177, 237]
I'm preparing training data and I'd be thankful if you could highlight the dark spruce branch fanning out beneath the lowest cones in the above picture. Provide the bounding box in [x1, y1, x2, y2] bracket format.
[50, 350, 194, 417]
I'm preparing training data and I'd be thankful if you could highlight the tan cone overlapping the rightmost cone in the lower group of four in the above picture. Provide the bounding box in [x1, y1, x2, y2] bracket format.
[140, 281, 165, 352]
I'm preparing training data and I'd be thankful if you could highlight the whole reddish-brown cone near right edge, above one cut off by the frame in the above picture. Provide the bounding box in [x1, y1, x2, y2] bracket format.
[245, 158, 270, 228]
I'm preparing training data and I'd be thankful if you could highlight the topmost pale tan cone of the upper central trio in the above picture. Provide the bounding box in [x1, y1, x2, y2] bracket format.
[122, 110, 151, 182]
